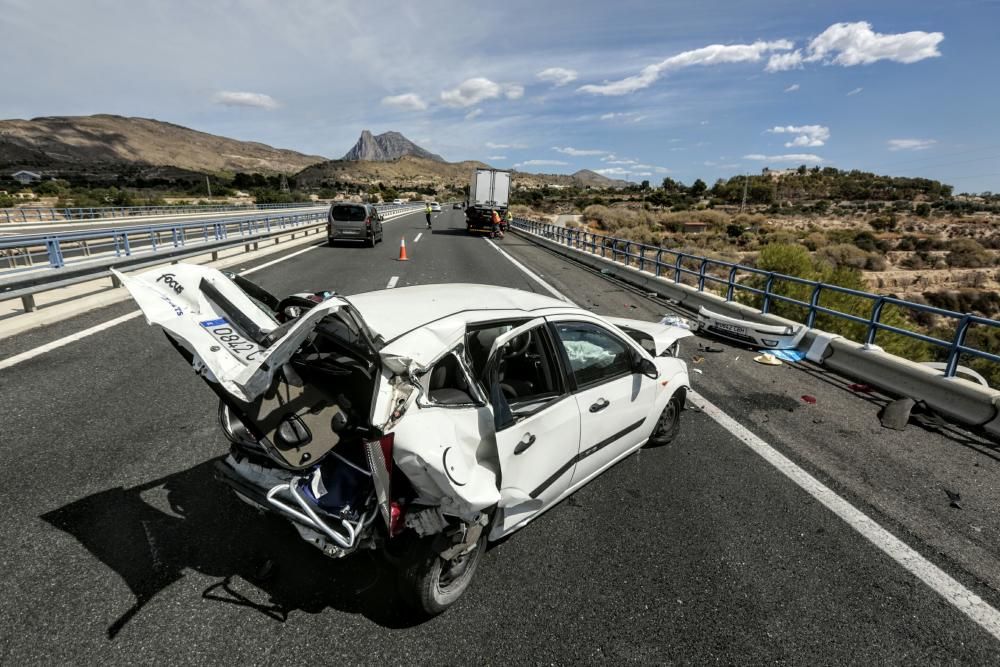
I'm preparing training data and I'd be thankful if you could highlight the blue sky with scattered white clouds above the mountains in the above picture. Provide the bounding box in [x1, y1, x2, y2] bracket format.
[0, 0, 1000, 192]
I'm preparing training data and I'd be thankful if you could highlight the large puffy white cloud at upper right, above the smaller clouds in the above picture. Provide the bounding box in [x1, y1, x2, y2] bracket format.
[806, 21, 944, 67]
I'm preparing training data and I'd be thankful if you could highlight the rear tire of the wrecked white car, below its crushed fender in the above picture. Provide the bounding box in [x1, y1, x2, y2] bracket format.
[399, 528, 489, 616]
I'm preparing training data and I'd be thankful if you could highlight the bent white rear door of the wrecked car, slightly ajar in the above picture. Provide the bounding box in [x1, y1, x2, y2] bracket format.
[484, 318, 580, 539]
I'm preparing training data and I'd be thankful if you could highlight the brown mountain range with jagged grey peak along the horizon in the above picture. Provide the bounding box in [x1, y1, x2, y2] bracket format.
[0, 114, 625, 187]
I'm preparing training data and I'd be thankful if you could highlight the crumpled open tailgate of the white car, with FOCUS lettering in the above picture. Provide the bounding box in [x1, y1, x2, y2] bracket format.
[115, 264, 381, 470]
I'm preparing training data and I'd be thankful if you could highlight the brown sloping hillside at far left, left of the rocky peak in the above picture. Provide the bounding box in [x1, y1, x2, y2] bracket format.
[0, 114, 325, 175]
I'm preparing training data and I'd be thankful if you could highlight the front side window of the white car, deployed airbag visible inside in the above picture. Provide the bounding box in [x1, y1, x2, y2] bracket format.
[555, 322, 632, 387]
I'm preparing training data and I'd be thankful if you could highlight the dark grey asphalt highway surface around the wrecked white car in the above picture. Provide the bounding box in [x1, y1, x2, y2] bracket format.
[0, 210, 1000, 665]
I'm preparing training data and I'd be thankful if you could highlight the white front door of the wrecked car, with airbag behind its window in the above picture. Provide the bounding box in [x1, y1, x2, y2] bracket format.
[552, 316, 657, 487]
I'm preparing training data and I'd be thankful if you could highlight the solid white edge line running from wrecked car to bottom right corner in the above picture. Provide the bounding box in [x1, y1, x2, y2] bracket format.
[688, 391, 1000, 639]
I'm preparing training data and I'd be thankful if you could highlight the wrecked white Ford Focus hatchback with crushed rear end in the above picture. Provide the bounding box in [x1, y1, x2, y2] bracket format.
[117, 264, 691, 614]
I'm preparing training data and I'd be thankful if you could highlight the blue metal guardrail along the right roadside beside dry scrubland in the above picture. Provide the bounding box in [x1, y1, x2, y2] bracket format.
[513, 218, 1000, 378]
